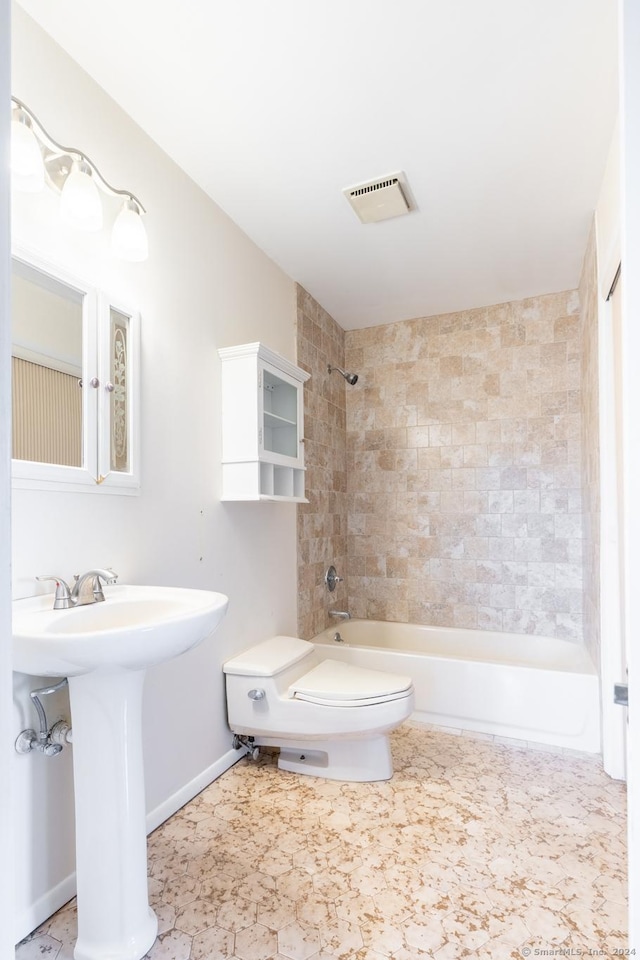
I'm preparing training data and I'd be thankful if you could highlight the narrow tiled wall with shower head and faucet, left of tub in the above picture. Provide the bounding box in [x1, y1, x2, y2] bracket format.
[297, 286, 353, 640]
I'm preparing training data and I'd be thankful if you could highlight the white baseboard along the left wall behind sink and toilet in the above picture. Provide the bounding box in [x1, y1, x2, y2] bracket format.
[15, 750, 245, 943]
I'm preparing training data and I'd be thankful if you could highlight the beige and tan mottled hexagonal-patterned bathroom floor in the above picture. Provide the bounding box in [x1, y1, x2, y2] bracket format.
[16, 723, 626, 960]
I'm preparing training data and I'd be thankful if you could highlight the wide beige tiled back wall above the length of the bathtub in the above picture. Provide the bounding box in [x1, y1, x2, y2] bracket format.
[346, 291, 583, 641]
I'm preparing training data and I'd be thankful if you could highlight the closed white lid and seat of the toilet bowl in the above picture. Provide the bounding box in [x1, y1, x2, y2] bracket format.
[289, 660, 412, 707]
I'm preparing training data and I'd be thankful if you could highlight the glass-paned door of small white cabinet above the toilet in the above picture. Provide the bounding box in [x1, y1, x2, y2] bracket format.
[258, 362, 303, 466]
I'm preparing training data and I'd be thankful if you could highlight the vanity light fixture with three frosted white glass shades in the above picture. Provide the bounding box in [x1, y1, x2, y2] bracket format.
[11, 97, 149, 261]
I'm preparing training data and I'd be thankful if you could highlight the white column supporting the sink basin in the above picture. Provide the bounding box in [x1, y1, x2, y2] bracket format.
[69, 667, 158, 960]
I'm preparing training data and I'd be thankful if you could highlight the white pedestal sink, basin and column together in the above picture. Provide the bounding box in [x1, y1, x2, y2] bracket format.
[13, 585, 228, 960]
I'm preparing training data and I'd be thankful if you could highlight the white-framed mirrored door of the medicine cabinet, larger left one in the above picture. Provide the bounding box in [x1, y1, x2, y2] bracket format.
[11, 250, 98, 489]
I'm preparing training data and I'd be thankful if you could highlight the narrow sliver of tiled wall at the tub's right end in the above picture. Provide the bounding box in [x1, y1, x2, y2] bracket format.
[579, 227, 600, 664]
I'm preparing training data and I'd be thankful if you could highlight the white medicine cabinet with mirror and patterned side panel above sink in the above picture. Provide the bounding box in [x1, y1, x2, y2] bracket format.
[11, 251, 139, 493]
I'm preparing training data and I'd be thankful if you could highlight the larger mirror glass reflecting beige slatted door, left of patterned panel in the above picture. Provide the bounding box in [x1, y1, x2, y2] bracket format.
[11, 258, 85, 467]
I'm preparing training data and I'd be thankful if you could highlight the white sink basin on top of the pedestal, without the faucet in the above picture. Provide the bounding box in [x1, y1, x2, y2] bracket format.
[13, 584, 228, 677]
